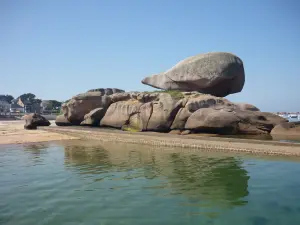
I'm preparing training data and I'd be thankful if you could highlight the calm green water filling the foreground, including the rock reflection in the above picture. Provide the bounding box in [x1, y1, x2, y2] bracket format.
[0, 141, 300, 225]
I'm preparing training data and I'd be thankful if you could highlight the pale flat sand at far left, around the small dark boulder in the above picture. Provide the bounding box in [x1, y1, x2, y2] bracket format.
[0, 120, 78, 144]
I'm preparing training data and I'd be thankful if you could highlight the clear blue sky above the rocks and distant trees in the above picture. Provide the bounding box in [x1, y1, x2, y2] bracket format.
[0, 0, 300, 111]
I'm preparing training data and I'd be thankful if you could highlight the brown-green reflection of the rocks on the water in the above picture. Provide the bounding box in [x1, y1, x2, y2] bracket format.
[65, 143, 249, 206]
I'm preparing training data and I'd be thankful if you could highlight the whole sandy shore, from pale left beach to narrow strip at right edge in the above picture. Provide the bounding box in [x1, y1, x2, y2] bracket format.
[0, 120, 300, 156]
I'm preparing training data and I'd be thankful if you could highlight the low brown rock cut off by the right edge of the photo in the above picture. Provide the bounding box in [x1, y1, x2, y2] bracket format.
[271, 122, 300, 137]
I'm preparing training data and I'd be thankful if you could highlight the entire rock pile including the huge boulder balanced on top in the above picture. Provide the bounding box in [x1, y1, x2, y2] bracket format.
[52, 52, 287, 134]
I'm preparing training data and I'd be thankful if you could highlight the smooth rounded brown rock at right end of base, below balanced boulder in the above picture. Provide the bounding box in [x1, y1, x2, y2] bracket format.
[185, 108, 286, 134]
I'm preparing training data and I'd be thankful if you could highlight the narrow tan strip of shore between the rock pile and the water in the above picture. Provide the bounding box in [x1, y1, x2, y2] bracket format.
[40, 127, 300, 156]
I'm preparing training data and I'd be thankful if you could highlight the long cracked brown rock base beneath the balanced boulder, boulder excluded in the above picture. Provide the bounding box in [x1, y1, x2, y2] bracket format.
[57, 91, 286, 134]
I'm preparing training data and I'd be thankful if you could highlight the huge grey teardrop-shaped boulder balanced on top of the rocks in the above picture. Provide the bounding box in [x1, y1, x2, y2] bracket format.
[142, 52, 245, 97]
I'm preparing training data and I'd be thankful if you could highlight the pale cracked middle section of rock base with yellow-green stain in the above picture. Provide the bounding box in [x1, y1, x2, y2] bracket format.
[101, 92, 180, 131]
